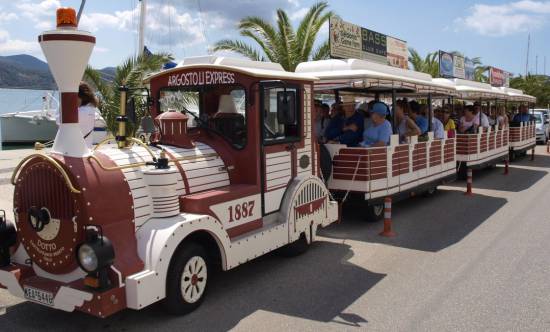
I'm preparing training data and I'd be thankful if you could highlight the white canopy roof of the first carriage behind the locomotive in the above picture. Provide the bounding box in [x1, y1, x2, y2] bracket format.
[296, 59, 456, 96]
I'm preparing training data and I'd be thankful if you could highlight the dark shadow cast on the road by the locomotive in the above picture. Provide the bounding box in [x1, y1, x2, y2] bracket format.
[0, 242, 385, 331]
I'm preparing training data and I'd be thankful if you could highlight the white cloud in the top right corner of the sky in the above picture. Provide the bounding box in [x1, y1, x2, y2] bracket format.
[455, 0, 550, 37]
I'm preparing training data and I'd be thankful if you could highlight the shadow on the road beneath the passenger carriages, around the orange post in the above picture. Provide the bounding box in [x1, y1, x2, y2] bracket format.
[320, 190, 506, 252]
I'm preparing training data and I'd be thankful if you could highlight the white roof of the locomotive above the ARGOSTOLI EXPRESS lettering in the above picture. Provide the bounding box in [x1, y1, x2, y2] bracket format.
[145, 56, 317, 83]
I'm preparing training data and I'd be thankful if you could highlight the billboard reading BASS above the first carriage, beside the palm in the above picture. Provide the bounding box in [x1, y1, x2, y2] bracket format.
[329, 17, 409, 68]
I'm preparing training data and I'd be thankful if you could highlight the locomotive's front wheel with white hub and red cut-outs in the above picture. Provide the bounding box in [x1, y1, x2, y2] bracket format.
[164, 243, 208, 315]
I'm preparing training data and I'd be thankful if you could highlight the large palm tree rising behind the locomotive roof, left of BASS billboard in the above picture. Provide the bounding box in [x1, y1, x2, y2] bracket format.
[212, 2, 334, 71]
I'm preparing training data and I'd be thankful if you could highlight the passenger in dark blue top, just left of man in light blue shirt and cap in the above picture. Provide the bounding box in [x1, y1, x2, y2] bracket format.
[326, 102, 364, 146]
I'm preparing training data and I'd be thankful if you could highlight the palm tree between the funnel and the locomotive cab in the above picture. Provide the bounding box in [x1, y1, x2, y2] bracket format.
[84, 53, 173, 136]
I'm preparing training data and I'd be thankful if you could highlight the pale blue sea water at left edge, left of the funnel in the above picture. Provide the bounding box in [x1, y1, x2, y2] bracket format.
[0, 89, 58, 150]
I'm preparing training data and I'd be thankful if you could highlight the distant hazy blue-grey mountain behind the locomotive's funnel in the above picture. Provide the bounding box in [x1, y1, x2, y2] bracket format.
[0, 54, 115, 90]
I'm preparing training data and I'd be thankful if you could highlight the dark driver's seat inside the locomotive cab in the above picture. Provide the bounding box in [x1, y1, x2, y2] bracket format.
[212, 95, 246, 145]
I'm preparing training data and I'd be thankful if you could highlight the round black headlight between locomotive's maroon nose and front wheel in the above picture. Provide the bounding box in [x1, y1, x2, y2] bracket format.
[76, 233, 115, 273]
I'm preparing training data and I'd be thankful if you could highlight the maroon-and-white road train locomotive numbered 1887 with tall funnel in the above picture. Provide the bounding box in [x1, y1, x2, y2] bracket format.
[0, 9, 338, 317]
